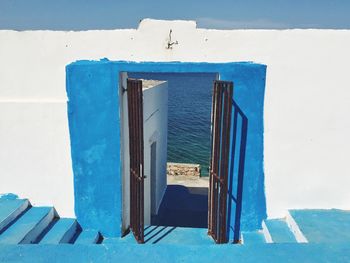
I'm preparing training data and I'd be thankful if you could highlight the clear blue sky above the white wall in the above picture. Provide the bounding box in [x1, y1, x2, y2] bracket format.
[0, 0, 350, 30]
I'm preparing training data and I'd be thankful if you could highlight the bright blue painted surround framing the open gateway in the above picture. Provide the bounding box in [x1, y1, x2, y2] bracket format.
[66, 59, 266, 237]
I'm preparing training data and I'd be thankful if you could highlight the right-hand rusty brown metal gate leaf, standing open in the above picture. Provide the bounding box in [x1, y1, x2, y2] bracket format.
[208, 80, 233, 244]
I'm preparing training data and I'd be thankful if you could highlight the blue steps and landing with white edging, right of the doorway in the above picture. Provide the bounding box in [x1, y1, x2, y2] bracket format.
[242, 209, 350, 245]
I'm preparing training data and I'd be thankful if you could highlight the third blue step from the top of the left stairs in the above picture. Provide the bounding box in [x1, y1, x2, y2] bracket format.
[40, 218, 79, 244]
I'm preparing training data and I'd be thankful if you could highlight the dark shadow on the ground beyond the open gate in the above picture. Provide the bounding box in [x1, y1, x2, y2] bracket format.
[152, 185, 208, 228]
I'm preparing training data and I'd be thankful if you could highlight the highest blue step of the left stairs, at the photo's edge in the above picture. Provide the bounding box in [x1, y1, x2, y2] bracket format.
[0, 199, 30, 233]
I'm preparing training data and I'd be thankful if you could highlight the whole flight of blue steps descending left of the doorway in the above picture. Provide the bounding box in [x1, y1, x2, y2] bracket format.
[0, 198, 103, 245]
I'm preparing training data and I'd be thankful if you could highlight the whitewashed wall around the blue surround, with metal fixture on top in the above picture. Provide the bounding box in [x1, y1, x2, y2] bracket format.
[0, 20, 350, 220]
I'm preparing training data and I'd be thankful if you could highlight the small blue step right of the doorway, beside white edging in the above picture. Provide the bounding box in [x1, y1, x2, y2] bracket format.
[265, 219, 297, 243]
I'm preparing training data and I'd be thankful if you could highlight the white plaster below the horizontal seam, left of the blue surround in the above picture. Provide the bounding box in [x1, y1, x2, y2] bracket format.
[0, 102, 74, 215]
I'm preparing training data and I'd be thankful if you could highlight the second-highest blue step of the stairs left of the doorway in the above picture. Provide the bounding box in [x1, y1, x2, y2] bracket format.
[0, 207, 56, 244]
